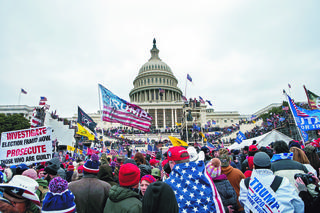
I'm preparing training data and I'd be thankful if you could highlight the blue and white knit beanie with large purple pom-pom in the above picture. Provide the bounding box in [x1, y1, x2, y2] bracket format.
[42, 177, 76, 213]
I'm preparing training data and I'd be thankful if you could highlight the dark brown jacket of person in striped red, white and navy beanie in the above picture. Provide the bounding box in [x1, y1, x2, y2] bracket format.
[69, 174, 111, 213]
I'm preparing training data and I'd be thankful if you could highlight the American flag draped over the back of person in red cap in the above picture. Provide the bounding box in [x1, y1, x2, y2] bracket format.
[165, 161, 224, 213]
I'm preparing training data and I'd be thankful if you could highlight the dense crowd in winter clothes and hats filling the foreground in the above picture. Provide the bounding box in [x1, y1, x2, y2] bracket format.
[0, 137, 320, 213]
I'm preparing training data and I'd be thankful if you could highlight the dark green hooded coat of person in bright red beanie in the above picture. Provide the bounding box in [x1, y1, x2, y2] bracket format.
[104, 185, 142, 213]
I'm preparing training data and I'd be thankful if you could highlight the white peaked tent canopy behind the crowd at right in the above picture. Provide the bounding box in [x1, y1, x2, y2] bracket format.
[228, 130, 293, 150]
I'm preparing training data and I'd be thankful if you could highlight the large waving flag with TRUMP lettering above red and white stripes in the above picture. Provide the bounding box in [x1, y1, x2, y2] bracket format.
[99, 84, 152, 132]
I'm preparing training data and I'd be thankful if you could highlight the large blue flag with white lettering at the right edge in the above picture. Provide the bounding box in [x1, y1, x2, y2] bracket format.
[287, 95, 320, 131]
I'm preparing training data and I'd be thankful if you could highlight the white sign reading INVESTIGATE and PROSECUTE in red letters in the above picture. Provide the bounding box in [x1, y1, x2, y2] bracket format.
[0, 127, 52, 165]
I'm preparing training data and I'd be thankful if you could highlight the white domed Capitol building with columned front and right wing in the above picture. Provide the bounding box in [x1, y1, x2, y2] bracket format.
[129, 39, 243, 129]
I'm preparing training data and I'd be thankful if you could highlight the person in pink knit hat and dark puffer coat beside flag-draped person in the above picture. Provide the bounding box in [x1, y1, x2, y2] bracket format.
[206, 158, 238, 212]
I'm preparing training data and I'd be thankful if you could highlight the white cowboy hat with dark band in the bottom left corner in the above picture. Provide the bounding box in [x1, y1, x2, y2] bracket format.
[0, 175, 41, 208]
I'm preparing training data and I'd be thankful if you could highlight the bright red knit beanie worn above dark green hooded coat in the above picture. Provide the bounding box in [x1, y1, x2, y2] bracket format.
[119, 163, 140, 187]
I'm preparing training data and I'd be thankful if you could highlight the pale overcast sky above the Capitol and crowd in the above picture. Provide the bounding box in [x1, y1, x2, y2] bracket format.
[0, 0, 320, 117]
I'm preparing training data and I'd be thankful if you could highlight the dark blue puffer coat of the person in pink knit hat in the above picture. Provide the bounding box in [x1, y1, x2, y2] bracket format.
[212, 174, 238, 212]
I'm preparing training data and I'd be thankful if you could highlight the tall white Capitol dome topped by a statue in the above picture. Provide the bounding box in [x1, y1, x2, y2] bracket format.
[129, 39, 182, 103]
